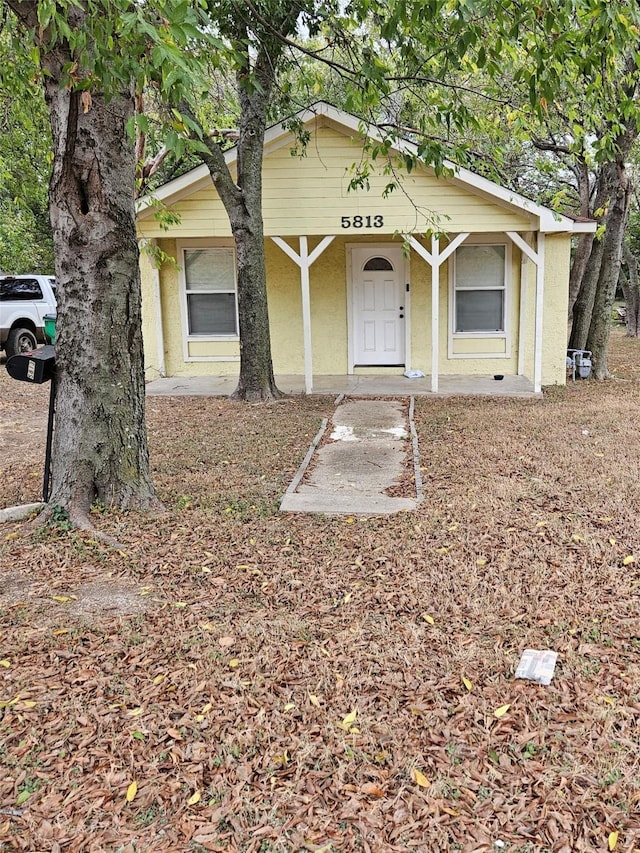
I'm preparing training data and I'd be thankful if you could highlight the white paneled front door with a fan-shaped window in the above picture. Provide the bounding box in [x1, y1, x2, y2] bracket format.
[351, 246, 406, 367]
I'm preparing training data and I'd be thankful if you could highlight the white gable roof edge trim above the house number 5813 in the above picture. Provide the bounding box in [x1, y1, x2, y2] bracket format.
[137, 101, 596, 233]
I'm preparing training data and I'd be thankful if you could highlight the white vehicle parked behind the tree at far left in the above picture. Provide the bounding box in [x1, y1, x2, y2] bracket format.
[0, 275, 56, 358]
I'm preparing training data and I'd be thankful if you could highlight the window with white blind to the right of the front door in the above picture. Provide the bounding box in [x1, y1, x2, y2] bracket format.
[453, 245, 507, 334]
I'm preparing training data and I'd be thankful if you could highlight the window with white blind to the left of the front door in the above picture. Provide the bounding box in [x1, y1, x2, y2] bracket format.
[184, 248, 238, 337]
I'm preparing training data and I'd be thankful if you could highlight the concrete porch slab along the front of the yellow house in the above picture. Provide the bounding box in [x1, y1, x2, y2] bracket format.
[146, 374, 542, 398]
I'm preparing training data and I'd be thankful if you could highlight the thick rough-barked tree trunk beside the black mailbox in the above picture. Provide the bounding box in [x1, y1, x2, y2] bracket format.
[41, 48, 159, 523]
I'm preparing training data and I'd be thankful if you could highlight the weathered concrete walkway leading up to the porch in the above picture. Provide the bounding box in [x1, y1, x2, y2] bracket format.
[280, 400, 422, 515]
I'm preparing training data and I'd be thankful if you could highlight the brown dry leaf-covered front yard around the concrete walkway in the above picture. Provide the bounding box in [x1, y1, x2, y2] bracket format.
[0, 336, 640, 853]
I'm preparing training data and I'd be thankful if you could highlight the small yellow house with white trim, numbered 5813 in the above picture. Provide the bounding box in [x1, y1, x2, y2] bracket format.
[138, 103, 595, 393]
